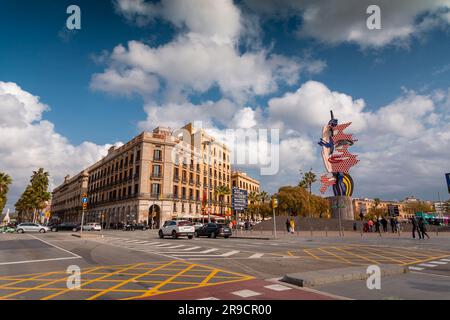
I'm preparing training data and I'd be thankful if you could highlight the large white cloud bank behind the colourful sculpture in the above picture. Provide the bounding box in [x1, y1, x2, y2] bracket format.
[269, 81, 450, 198]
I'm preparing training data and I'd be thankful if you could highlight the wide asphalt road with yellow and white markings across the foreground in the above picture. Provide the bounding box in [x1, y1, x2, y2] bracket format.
[0, 231, 450, 299]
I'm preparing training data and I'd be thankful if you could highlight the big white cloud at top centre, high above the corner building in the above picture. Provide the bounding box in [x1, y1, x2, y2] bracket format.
[91, 0, 325, 102]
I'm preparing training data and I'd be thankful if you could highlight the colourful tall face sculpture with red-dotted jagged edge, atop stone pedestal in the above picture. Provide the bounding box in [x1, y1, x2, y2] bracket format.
[319, 114, 359, 196]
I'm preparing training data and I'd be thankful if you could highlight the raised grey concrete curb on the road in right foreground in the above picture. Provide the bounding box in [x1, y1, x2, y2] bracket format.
[281, 264, 409, 287]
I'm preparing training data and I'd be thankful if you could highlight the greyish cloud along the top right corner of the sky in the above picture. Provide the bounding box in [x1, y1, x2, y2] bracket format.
[245, 0, 450, 48]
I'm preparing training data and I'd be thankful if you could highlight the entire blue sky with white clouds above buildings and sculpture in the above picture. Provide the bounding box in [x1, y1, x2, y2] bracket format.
[0, 0, 450, 208]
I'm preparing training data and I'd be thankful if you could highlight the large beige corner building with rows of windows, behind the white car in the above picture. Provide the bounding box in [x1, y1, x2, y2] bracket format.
[53, 124, 231, 228]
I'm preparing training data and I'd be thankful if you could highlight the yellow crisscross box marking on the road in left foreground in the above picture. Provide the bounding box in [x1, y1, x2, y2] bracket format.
[0, 260, 254, 300]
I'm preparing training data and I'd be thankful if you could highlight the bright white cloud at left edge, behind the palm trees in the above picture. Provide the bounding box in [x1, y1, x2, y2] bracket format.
[0, 81, 118, 209]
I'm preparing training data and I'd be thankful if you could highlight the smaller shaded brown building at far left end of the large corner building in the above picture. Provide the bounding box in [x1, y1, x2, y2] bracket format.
[50, 170, 89, 221]
